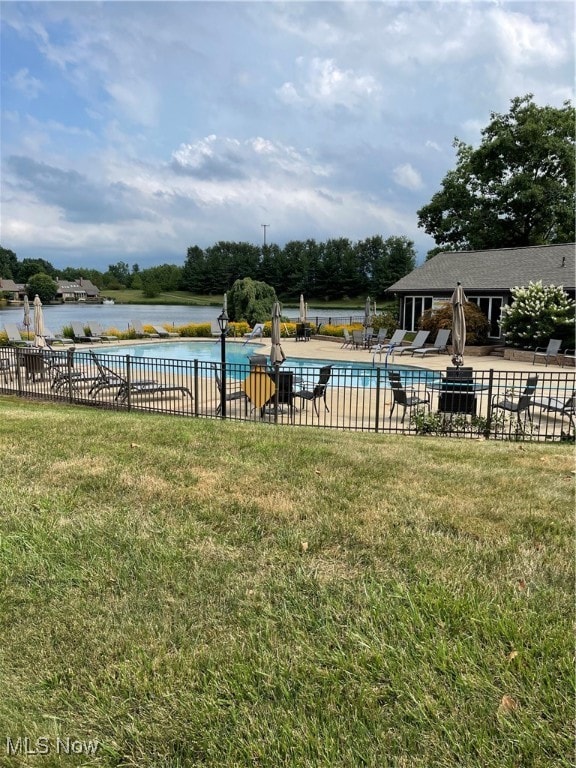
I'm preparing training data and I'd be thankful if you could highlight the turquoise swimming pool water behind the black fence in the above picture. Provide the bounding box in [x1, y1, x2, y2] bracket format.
[98, 339, 439, 387]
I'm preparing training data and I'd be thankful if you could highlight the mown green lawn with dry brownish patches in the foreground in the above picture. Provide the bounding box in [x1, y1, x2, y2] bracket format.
[0, 398, 574, 768]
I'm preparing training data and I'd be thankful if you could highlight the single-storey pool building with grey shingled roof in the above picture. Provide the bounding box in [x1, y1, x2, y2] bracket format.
[387, 243, 576, 340]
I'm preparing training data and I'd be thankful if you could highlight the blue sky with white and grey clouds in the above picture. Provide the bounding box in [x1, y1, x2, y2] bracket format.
[0, 0, 575, 271]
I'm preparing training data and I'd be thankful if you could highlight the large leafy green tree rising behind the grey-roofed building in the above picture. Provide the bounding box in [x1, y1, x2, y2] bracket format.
[417, 94, 576, 255]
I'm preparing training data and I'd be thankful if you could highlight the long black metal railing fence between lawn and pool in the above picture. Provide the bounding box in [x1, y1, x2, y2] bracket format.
[0, 347, 576, 441]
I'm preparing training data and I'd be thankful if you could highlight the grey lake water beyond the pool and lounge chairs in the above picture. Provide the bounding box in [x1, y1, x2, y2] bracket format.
[0, 304, 362, 333]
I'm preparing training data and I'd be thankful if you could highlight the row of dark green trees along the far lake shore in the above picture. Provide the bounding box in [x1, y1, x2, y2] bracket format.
[0, 235, 416, 300]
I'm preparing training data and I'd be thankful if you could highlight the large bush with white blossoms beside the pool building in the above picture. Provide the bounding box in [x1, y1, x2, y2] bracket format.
[500, 280, 576, 349]
